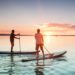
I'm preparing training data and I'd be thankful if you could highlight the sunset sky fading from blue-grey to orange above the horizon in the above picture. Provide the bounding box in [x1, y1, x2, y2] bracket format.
[0, 0, 75, 34]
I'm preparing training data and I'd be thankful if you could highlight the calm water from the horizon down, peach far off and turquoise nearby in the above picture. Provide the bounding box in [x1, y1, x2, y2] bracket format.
[0, 36, 75, 75]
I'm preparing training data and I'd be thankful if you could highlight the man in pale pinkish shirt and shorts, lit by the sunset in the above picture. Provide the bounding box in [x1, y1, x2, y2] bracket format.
[35, 29, 44, 64]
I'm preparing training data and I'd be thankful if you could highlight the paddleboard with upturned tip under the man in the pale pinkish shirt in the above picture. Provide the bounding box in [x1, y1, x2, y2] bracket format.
[21, 51, 67, 62]
